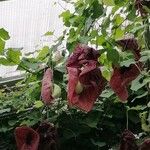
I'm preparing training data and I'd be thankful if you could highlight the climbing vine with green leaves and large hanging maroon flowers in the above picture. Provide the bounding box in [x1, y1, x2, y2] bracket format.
[0, 0, 150, 150]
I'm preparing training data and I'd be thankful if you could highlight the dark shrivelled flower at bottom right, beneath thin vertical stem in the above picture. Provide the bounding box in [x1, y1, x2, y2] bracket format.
[119, 129, 138, 150]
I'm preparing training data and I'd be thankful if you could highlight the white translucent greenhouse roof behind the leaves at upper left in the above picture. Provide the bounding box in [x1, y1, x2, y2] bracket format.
[0, 0, 67, 78]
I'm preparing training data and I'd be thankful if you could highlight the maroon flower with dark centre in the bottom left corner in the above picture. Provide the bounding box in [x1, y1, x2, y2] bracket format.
[15, 127, 39, 150]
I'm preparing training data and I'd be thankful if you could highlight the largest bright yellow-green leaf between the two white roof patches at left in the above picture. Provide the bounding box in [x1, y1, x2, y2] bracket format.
[7, 48, 21, 64]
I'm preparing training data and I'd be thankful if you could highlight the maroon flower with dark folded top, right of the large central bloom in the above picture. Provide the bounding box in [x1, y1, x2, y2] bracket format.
[110, 39, 142, 102]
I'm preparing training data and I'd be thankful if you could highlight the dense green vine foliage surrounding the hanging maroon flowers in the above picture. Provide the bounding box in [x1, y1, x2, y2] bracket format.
[0, 0, 150, 150]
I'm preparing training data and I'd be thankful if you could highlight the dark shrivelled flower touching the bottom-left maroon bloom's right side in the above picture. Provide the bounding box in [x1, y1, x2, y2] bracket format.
[37, 122, 57, 150]
